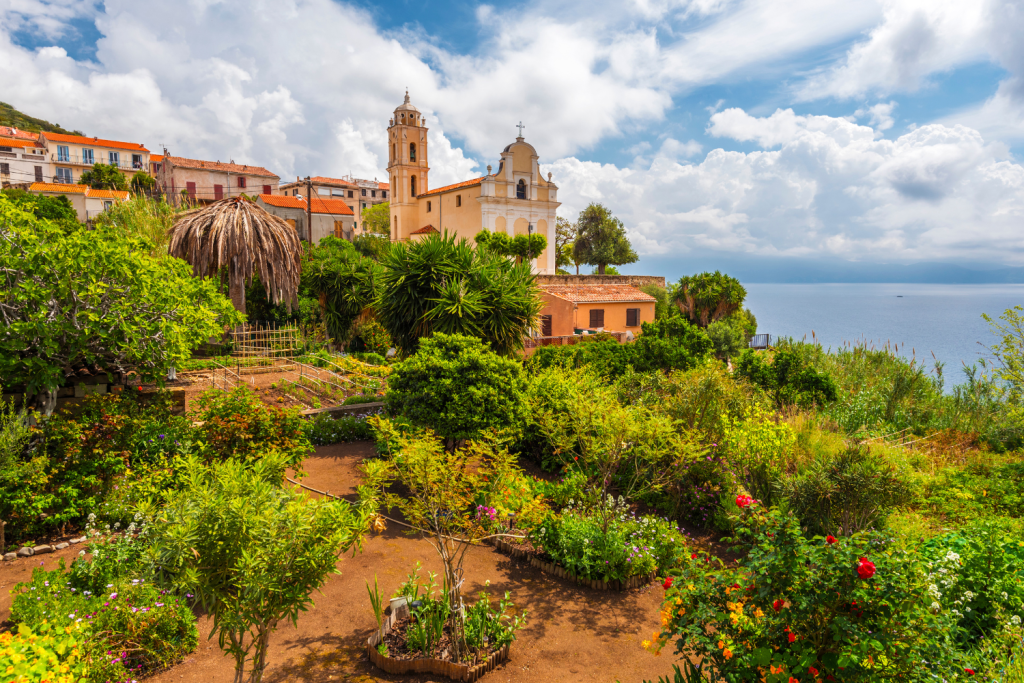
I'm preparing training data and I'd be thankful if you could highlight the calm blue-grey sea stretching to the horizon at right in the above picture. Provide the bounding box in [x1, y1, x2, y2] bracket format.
[743, 283, 1024, 391]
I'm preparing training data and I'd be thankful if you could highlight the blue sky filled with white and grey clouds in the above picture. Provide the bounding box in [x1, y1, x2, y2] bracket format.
[0, 0, 1024, 282]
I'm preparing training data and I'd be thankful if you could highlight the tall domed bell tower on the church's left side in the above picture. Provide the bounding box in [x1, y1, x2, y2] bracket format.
[387, 90, 430, 240]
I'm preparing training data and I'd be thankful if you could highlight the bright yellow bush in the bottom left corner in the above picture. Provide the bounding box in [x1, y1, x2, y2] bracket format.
[0, 622, 85, 683]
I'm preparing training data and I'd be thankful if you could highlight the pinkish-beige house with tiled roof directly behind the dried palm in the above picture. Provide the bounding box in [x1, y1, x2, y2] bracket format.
[156, 150, 281, 205]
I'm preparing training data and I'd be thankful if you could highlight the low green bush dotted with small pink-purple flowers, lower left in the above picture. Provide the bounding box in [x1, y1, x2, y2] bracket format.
[11, 561, 199, 681]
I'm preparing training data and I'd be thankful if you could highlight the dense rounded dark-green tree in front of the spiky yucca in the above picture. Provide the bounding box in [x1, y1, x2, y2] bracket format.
[385, 333, 526, 445]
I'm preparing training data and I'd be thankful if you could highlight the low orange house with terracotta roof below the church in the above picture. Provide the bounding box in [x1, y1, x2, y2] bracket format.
[539, 285, 656, 337]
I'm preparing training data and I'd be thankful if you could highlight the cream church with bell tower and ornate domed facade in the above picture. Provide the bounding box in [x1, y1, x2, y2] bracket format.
[388, 92, 559, 274]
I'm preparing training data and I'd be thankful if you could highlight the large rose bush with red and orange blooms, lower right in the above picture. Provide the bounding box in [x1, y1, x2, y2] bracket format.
[645, 503, 963, 683]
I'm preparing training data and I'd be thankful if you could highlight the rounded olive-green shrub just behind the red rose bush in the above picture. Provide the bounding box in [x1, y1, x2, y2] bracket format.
[779, 446, 913, 536]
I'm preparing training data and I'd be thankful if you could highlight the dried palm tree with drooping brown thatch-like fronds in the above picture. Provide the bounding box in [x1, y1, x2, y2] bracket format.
[168, 197, 301, 313]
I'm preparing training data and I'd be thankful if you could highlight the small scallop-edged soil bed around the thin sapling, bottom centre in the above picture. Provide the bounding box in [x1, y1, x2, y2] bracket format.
[367, 613, 510, 681]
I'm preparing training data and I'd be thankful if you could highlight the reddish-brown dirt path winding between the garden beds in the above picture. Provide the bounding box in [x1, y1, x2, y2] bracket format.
[0, 442, 673, 683]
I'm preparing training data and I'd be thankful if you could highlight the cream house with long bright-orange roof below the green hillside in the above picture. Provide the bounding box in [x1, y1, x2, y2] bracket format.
[39, 131, 150, 183]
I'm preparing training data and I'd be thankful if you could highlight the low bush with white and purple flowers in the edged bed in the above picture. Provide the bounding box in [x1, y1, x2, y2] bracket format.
[529, 498, 684, 581]
